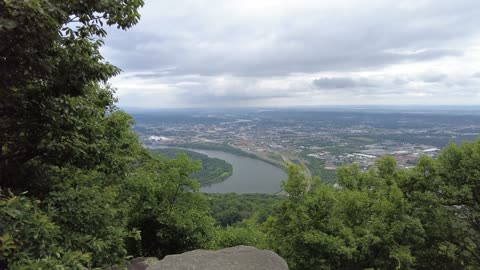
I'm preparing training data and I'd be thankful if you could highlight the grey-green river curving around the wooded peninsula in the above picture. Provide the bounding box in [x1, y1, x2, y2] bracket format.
[148, 146, 287, 194]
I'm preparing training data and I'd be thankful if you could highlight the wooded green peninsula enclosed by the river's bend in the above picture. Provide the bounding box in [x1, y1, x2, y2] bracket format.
[150, 148, 233, 186]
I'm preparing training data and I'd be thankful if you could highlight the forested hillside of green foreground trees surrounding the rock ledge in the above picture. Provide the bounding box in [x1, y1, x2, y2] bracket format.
[0, 0, 480, 270]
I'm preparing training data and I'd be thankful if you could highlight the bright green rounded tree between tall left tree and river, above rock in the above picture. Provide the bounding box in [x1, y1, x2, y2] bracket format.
[122, 155, 213, 257]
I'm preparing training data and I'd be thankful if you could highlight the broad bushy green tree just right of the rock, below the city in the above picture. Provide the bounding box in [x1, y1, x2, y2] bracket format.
[267, 160, 424, 269]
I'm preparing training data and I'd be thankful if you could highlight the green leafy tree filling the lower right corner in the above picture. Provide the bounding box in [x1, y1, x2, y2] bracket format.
[399, 140, 480, 269]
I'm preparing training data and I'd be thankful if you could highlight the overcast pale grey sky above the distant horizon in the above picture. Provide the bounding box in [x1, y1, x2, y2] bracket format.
[102, 0, 480, 109]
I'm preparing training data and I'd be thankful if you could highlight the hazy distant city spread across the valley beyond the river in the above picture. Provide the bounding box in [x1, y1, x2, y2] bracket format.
[132, 108, 480, 181]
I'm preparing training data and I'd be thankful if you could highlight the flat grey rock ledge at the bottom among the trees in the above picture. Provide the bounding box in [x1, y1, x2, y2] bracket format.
[128, 246, 288, 270]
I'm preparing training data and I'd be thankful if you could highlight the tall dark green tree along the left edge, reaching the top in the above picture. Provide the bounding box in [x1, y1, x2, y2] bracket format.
[0, 0, 143, 268]
